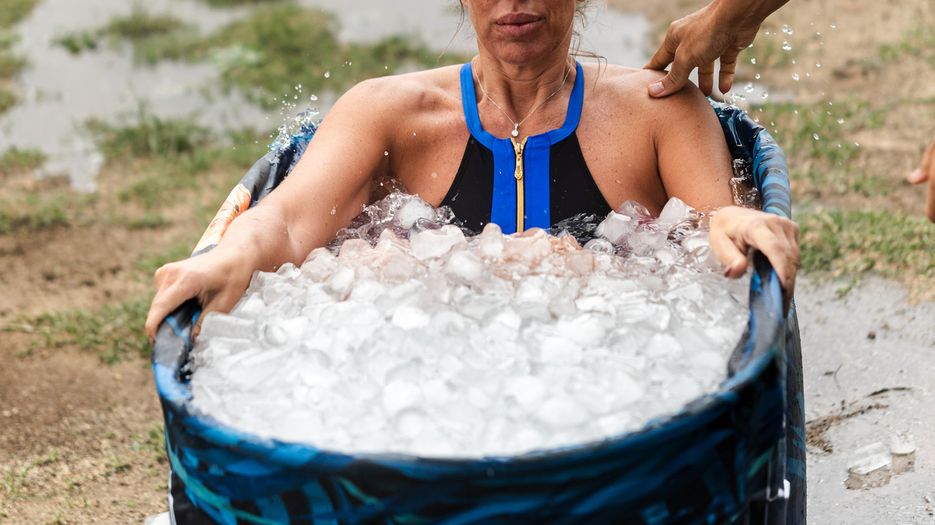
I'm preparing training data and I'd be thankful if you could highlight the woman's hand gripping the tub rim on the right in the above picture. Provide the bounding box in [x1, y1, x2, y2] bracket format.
[710, 206, 799, 299]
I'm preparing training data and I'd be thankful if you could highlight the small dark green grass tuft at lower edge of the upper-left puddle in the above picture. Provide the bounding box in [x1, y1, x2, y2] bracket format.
[87, 108, 212, 160]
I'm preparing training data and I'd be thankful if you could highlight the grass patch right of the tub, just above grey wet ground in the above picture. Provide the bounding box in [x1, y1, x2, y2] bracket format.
[799, 210, 935, 280]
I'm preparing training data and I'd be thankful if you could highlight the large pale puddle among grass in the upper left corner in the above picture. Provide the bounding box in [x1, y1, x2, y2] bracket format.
[0, 0, 269, 191]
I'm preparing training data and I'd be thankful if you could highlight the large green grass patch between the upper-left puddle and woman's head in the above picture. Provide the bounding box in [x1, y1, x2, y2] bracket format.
[143, 3, 463, 109]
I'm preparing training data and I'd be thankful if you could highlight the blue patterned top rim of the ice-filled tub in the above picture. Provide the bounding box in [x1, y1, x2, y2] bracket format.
[152, 102, 790, 466]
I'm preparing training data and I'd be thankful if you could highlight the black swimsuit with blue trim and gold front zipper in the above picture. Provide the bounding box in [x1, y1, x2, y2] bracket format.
[442, 63, 611, 233]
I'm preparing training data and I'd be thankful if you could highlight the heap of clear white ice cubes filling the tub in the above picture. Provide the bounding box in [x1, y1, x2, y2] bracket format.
[192, 193, 747, 457]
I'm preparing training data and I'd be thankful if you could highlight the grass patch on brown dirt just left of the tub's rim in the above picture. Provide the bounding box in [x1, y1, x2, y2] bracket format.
[11, 296, 150, 364]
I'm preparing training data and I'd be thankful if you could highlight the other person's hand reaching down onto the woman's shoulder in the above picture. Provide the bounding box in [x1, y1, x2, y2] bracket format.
[644, 0, 789, 97]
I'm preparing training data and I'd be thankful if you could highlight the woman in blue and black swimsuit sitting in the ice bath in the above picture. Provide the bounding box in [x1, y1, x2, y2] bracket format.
[146, 0, 798, 337]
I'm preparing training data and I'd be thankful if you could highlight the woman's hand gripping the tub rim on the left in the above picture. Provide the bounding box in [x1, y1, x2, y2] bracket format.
[145, 248, 253, 342]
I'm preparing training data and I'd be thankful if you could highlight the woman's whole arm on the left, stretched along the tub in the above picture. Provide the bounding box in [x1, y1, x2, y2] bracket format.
[145, 79, 398, 338]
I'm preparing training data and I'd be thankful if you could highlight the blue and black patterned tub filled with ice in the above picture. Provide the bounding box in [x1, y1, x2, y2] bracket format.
[153, 104, 805, 525]
